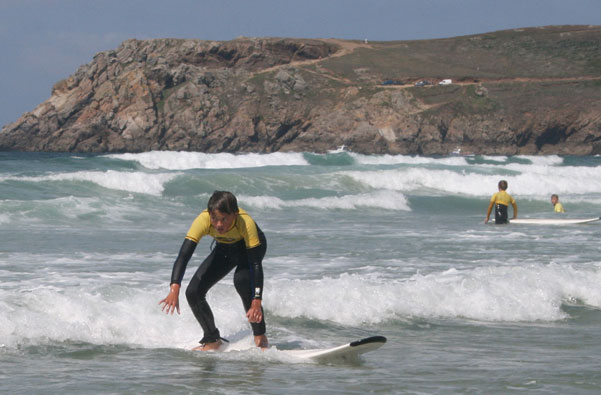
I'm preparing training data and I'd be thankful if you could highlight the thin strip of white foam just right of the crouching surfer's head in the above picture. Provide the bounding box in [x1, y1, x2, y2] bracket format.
[239, 190, 411, 211]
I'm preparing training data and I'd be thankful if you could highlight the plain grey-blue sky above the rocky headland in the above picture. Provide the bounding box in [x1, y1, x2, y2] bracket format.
[0, 0, 601, 126]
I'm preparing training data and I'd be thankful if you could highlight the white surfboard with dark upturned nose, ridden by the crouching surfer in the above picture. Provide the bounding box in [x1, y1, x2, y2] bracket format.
[280, 336, 386, 362]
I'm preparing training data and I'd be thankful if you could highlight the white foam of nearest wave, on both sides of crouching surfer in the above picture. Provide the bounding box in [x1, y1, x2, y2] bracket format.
[0, 254, 601, 348]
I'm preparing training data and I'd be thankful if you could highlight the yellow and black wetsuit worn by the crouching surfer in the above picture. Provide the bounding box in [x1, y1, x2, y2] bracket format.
[171, 209, 267, 343]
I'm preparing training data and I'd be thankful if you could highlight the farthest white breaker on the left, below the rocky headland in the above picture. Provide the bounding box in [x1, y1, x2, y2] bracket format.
[107, 151, 309, 170]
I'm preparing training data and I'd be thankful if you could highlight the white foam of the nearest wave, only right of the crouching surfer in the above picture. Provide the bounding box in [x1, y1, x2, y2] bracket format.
[265, 264, 601, 325]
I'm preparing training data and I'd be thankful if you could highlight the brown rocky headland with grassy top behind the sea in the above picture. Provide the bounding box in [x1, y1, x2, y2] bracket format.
[0, 26, 601, 155]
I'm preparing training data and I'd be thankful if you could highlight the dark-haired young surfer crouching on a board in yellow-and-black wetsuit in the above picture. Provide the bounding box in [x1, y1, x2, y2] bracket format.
[159, 191, 268, 351]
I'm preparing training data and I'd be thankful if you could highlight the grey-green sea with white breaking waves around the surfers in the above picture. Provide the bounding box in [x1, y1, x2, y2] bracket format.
[0, 152, 601, 394]
